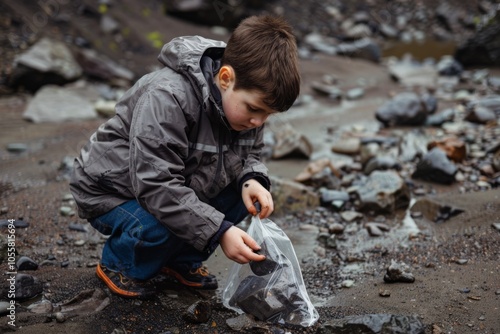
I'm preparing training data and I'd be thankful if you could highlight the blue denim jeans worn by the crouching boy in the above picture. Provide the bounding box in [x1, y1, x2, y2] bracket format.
[89, 186, 248, 280]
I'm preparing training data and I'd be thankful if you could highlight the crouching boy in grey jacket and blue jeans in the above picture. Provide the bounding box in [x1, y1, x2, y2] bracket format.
[70, 16, 300, 298]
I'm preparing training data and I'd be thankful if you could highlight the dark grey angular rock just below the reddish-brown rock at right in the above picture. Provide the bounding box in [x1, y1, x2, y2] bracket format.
[412, 147, 458, 184]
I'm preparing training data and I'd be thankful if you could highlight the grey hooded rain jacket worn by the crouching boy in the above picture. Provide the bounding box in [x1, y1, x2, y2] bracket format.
[70, 36, 267, 250]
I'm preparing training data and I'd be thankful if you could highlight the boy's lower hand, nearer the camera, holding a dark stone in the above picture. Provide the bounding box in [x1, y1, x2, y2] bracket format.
[219, 226, 266, 264]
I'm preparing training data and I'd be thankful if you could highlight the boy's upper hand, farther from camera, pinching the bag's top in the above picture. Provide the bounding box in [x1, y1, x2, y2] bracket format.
[241, 179, 274, 219]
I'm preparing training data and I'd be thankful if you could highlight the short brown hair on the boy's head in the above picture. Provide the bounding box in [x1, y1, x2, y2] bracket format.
[222, 15, 300, 111]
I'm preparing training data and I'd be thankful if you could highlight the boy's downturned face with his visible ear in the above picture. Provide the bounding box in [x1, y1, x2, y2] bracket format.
[216, 66, 277, 131]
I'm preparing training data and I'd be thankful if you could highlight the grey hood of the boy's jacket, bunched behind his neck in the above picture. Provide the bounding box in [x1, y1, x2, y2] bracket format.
[158, 36, 226, 103]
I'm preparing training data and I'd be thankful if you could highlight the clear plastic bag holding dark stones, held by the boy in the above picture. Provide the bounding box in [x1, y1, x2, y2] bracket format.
[222, 216, 319, 327]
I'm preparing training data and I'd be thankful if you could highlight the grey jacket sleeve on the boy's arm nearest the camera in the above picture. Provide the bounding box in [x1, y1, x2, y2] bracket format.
[129, 88, 224, 251]
